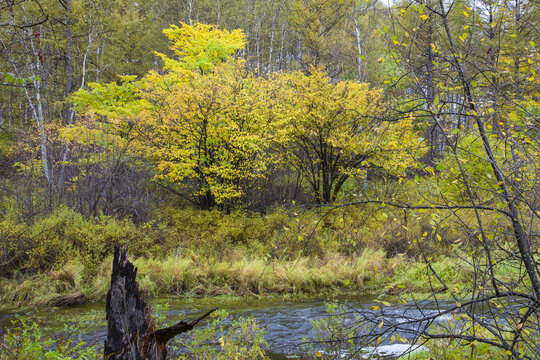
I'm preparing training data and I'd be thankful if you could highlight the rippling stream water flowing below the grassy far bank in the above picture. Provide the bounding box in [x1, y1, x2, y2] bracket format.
[0, 297, 451, 360]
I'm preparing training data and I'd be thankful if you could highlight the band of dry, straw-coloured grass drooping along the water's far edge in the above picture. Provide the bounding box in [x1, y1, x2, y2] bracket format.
[0, 246, 388, 305]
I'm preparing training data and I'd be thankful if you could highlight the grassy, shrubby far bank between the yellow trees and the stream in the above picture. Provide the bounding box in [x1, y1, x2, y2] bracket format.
[0, 204, 516, 306]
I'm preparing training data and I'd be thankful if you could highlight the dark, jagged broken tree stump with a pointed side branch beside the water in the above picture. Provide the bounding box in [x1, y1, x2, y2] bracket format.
[104, 247, 216, 360]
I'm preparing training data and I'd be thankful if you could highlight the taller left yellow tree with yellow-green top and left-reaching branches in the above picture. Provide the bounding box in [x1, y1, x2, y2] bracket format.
[68, 24, 266, 208]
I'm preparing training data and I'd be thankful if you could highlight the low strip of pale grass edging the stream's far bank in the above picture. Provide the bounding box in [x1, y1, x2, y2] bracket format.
[0, 248, 467, 307]
